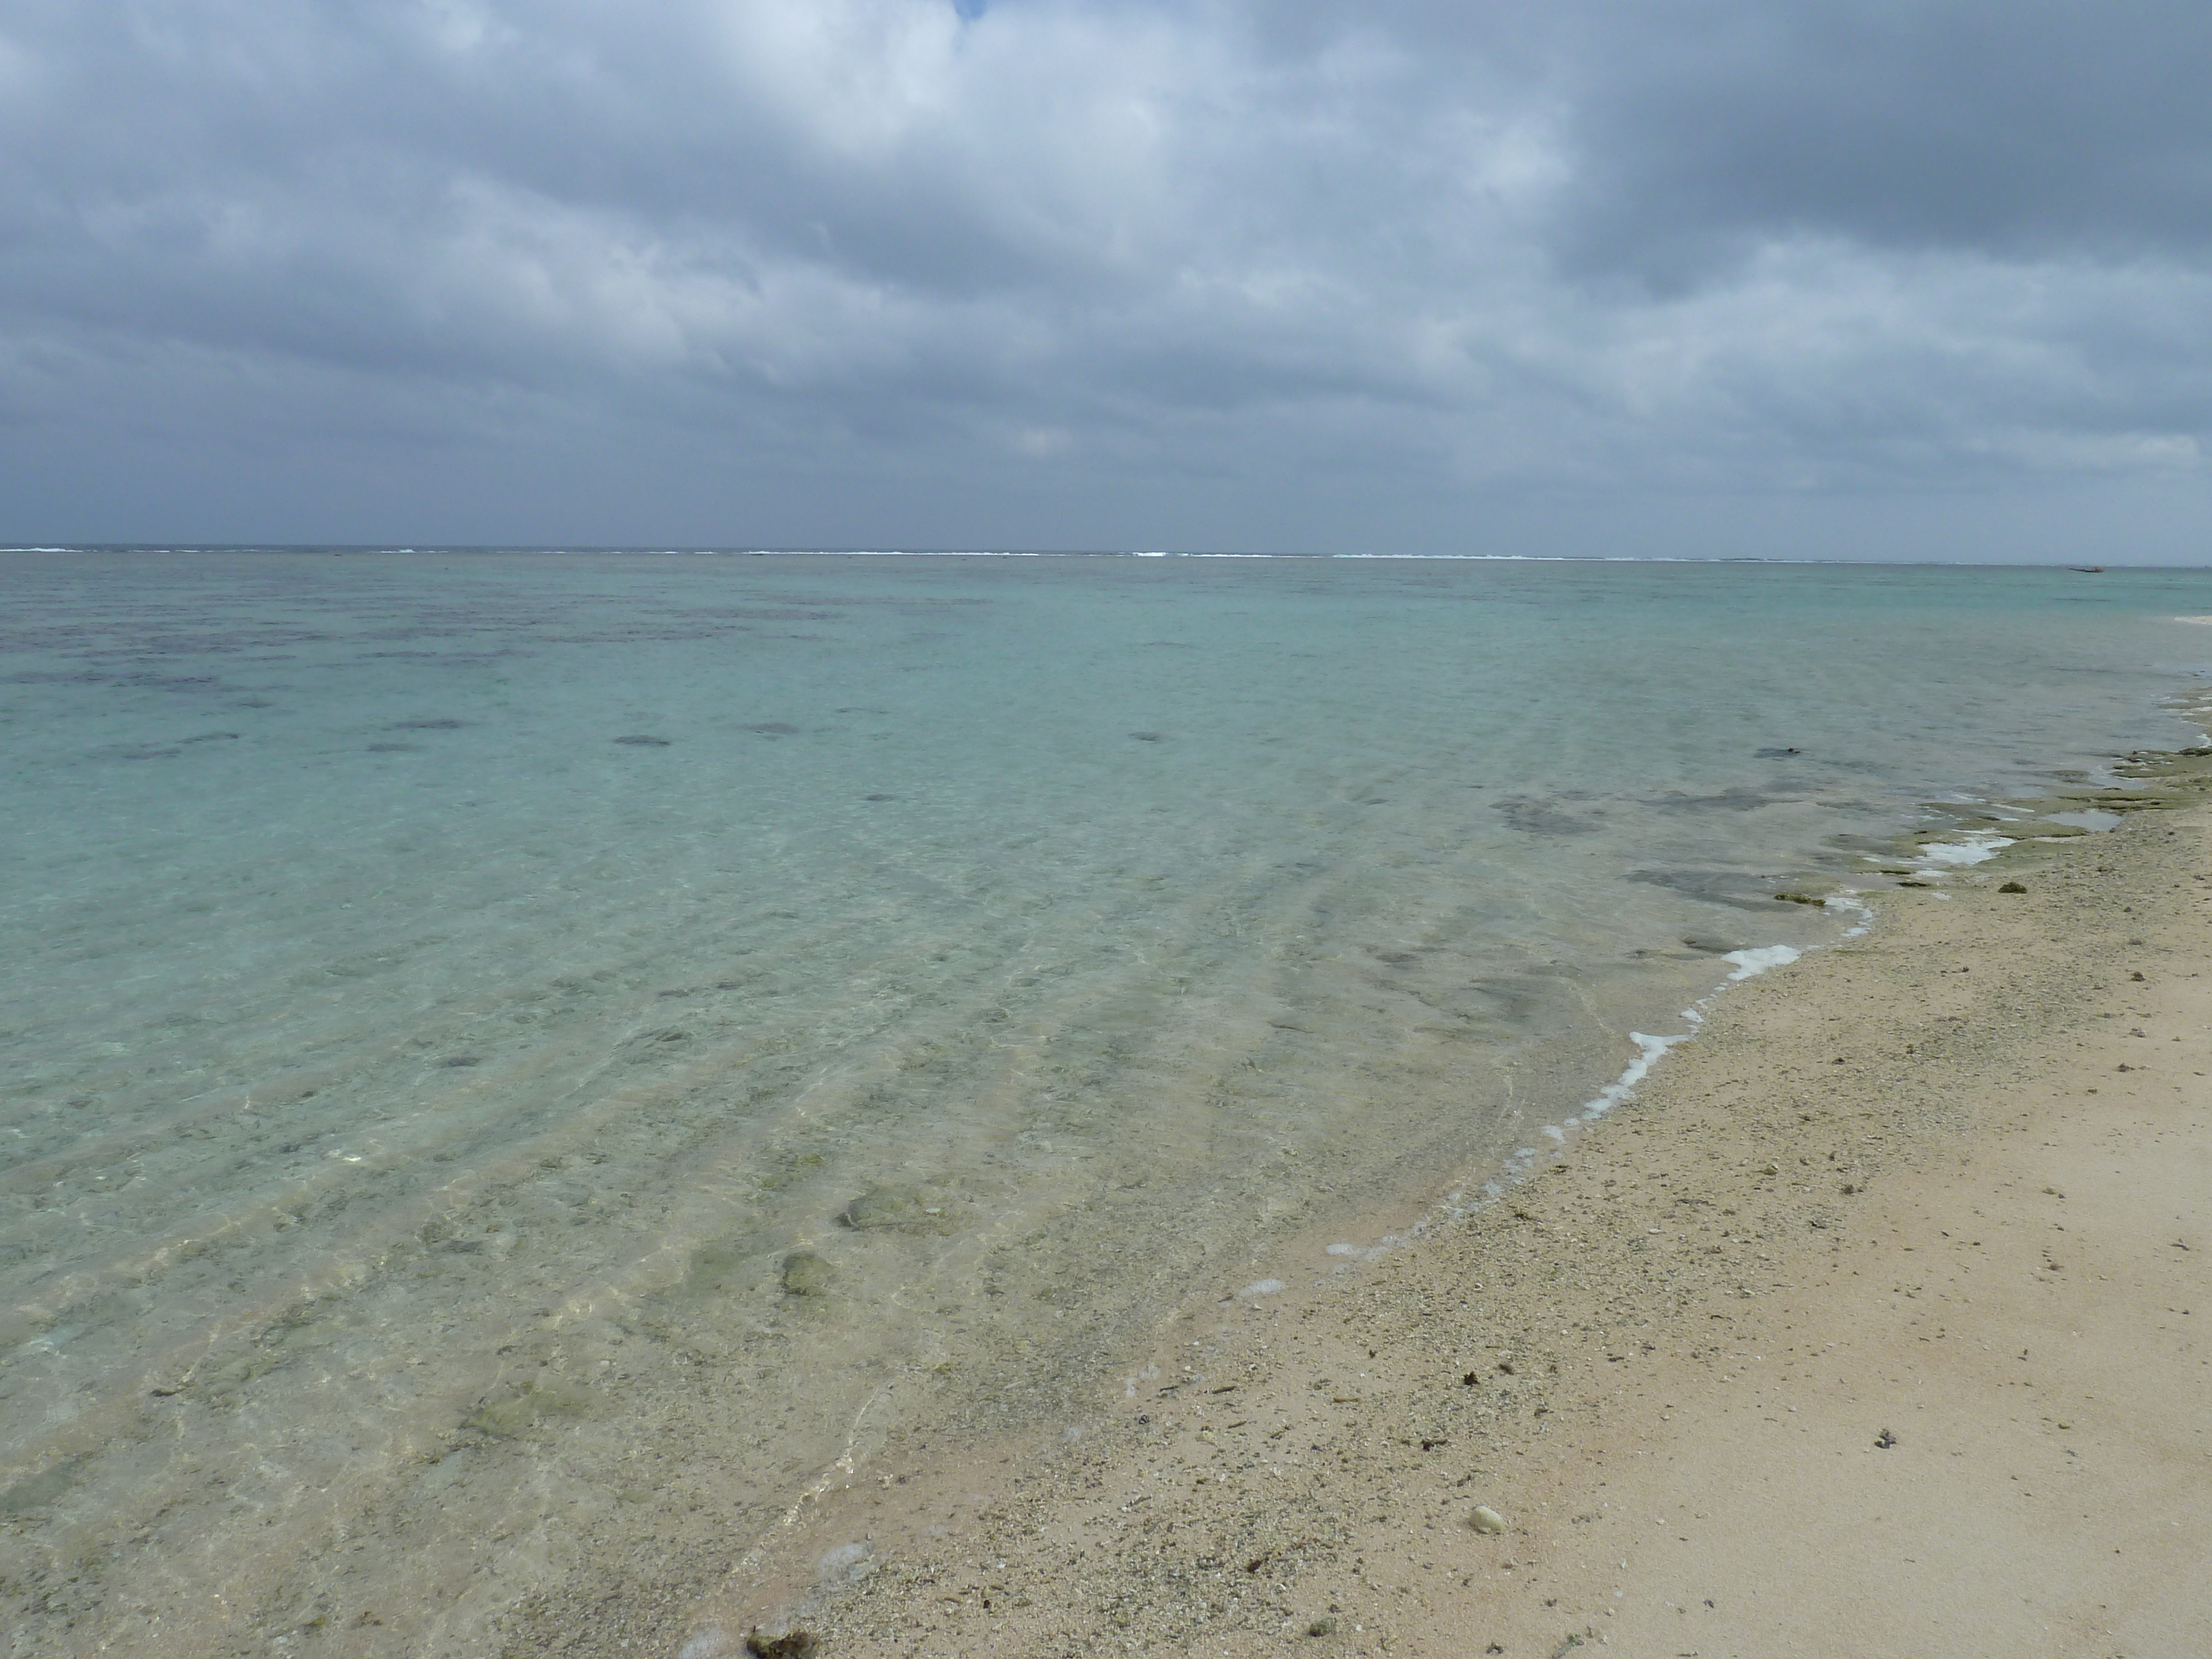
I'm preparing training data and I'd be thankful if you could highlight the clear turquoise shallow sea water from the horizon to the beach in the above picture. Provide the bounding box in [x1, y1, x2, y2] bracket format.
[13, 553, 2212, 1652]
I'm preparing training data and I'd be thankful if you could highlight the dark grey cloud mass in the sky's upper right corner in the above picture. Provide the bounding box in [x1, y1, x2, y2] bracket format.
[1568, 0, 2212, 280]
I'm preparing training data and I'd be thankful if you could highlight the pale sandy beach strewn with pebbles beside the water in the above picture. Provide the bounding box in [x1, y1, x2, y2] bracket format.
[686, 761, 2212, 1659]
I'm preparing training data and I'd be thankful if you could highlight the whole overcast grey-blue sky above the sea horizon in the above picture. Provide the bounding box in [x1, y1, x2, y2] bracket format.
[0, 0, 2212, 564]
